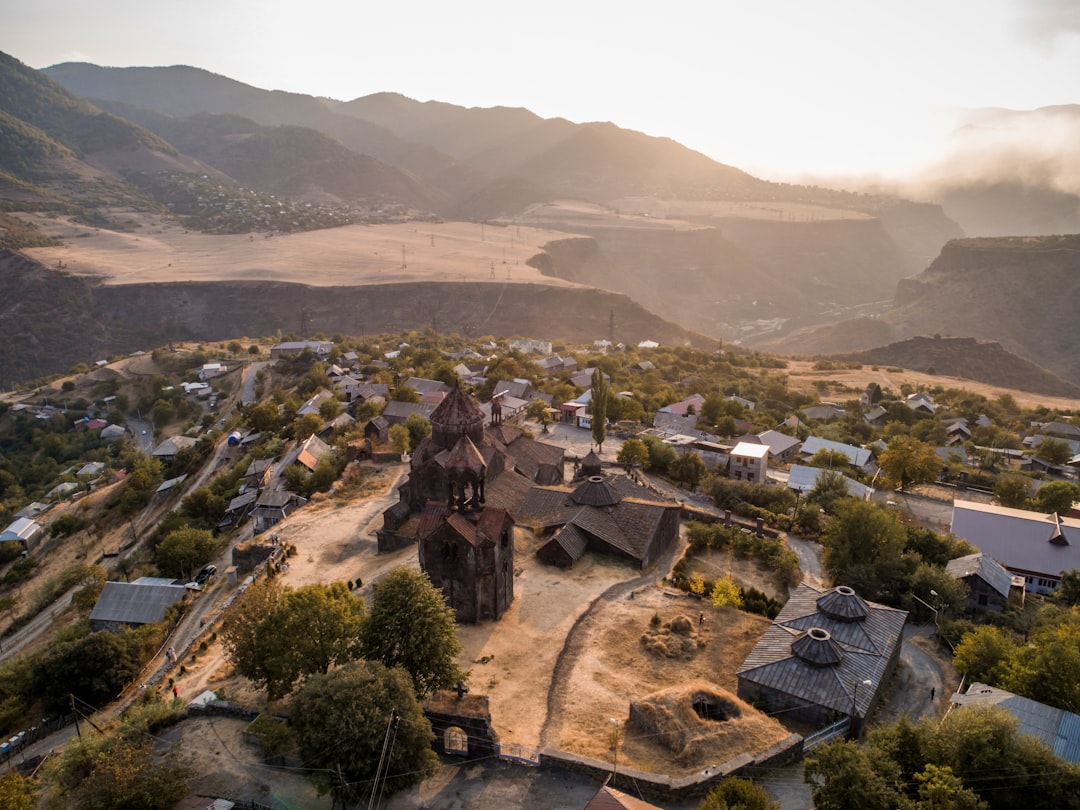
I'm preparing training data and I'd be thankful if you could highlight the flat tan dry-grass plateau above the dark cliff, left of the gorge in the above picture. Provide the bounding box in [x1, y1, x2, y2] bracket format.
[16, 214, 578, 286]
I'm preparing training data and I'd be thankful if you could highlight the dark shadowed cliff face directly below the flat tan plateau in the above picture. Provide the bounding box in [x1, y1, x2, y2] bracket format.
[0, 252, 703, 386]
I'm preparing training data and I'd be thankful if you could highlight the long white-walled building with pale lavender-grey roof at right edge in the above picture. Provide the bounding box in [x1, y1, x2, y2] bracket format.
[950, 499, 1080, 594]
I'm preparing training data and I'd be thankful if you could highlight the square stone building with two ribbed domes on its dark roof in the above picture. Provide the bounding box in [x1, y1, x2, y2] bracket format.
[735, 582, 907, 735]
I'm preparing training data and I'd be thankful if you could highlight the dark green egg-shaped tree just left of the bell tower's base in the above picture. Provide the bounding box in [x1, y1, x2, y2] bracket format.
[360, 568, 463, 697]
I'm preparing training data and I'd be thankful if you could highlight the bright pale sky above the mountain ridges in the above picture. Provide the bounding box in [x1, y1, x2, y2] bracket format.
[8, 0, 1080, 179]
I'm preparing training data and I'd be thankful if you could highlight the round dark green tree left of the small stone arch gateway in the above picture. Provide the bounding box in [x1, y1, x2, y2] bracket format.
[293, 661, 438, 801]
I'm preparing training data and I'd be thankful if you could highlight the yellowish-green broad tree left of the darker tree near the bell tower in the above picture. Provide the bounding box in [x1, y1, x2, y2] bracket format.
[221, 582, 364, 700]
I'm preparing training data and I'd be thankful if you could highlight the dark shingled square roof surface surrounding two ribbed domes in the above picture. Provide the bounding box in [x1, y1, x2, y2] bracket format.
[737, 583, 907, 717]
